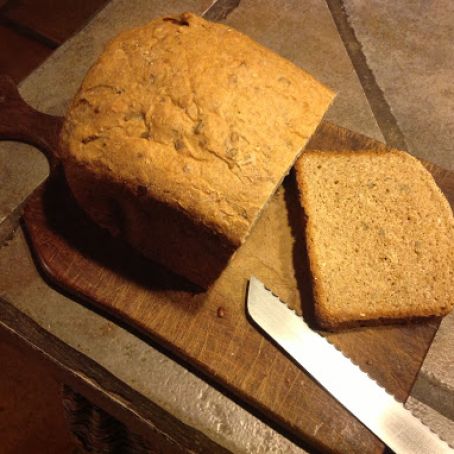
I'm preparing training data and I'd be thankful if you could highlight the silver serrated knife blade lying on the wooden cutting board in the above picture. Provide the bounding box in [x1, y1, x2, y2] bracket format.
[247, 277, 454, 454]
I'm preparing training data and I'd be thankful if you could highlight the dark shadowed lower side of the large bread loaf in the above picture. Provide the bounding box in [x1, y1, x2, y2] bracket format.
[65, 164, 237, 289]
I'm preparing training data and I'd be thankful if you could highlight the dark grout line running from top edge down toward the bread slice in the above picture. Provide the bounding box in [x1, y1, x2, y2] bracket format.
[326, 0, 408, 150]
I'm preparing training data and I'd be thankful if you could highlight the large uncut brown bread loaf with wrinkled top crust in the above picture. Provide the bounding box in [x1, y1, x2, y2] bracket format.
[61, 13, 333, 287]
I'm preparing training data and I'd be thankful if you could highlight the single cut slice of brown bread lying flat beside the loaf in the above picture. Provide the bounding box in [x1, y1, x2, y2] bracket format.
[296, 151, 454, 329]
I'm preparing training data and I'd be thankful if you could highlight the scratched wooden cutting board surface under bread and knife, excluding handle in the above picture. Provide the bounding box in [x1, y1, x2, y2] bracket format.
[19, 123, 454, 452]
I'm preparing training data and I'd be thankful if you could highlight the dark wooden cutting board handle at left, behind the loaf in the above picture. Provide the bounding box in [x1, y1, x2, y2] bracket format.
[0, 74, 63, 170]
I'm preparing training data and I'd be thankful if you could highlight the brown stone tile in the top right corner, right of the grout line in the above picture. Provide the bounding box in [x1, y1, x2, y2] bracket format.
[344, 0, 454, 169]
